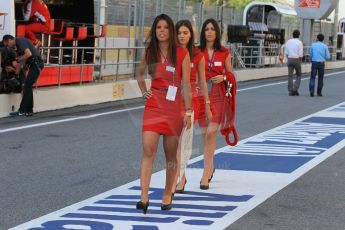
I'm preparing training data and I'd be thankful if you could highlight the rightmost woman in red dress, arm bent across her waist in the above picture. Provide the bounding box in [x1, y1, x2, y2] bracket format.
[199, 19, 232, 190]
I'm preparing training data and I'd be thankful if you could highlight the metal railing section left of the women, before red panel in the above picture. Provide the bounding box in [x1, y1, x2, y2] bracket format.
[36, 47, 144, 86]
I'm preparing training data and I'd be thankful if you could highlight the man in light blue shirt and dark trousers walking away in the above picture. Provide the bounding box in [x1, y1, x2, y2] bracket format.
[309, 34, 330, 97]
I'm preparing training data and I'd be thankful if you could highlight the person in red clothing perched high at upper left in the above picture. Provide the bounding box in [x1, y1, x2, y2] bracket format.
[22, 0, 50, 47]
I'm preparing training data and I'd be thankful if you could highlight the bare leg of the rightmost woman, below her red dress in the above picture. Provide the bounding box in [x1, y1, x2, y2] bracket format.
[201, 122, 219, 185]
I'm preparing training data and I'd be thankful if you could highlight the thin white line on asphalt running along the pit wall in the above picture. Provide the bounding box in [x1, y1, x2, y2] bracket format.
[0, 71, 345, 133]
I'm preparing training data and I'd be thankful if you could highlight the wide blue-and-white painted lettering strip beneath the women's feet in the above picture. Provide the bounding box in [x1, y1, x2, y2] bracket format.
[12, 103, 345, 230]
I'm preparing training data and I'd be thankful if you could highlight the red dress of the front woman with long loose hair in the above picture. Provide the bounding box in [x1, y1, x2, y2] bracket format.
[142, 47, 188, 136]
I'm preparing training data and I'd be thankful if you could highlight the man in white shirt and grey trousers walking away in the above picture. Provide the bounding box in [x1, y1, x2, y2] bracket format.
[285, 30, 303, 96]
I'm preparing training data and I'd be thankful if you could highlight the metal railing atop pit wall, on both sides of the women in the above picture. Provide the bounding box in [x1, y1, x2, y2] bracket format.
[2, 45, 342, 90]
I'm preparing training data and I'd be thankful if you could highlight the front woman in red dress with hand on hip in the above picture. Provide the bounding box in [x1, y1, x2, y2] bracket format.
[136, 14, 192, 213]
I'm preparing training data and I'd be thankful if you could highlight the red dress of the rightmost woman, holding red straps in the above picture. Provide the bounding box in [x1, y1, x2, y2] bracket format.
[199, 46, 230, 127]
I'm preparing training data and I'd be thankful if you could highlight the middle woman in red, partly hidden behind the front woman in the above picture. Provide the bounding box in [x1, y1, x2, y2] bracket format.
[175, 20, 212, 193]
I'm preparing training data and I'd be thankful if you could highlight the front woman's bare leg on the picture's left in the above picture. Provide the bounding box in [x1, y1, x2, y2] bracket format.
[140, 131, 159, 202]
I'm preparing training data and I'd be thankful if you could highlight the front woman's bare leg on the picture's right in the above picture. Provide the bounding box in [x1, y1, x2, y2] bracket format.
[162, 136, 179, 204]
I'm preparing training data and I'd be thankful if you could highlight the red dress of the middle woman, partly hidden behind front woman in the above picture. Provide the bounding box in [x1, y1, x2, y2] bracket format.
[190, 47, 204, 121]
